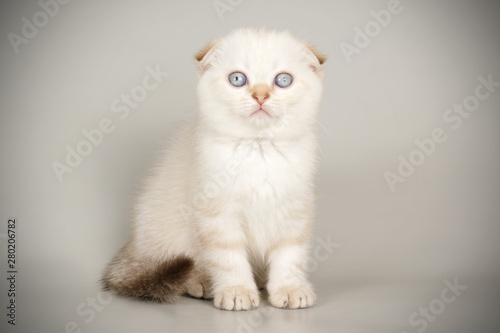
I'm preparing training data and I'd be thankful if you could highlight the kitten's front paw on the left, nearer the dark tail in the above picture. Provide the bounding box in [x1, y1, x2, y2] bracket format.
[214, 286, 260, 311]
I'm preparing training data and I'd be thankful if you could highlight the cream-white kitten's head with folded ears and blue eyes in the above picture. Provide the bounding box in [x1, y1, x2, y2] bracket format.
[195, 29, 325, 137]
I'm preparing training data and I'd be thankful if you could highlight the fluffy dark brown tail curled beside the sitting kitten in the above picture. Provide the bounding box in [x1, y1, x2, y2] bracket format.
[101, 249, 194, 303]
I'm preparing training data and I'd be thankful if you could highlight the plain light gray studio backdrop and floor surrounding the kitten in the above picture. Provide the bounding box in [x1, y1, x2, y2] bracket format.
[0, 0, 500, 333]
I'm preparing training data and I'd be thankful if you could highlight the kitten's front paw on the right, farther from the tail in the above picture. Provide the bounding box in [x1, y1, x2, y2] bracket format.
[269, 284, 316, 309]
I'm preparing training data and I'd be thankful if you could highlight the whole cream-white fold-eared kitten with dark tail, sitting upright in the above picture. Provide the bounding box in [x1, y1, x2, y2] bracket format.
[102, 28, 325, 310]
